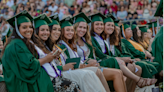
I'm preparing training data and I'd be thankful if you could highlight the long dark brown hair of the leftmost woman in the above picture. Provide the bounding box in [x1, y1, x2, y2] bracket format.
[1, 23, 38, 58]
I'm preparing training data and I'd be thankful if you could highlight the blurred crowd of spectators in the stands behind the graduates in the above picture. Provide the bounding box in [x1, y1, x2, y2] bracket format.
[0, 0, 163, 41]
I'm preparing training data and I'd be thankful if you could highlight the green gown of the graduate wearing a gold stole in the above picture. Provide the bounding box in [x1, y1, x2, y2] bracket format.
[121, 39, 159, 78]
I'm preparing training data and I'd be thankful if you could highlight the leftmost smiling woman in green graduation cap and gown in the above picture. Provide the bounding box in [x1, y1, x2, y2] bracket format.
[2, 11, 54, 92]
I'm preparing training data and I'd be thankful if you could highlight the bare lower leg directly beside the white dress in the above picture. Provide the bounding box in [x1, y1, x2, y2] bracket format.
[96, 69, 110, 92]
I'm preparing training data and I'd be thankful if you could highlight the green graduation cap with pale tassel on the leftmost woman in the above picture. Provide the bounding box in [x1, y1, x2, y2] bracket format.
[7, 10, 33, 39]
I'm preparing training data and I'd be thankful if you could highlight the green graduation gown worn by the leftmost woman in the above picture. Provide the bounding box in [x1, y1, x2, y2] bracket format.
[2, 39, 54, 92]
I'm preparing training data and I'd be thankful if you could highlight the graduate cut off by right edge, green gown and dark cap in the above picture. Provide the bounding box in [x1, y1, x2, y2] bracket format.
[152, 0, 163, 76]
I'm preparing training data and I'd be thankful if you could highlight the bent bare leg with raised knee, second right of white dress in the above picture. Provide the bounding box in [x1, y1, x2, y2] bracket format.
[103, 68, 127, 92]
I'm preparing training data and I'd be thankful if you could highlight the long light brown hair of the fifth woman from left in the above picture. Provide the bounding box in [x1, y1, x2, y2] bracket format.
[74, 22, 92, 46]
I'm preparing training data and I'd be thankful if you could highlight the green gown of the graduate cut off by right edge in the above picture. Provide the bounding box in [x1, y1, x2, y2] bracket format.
[152, 26, 163, 72]
